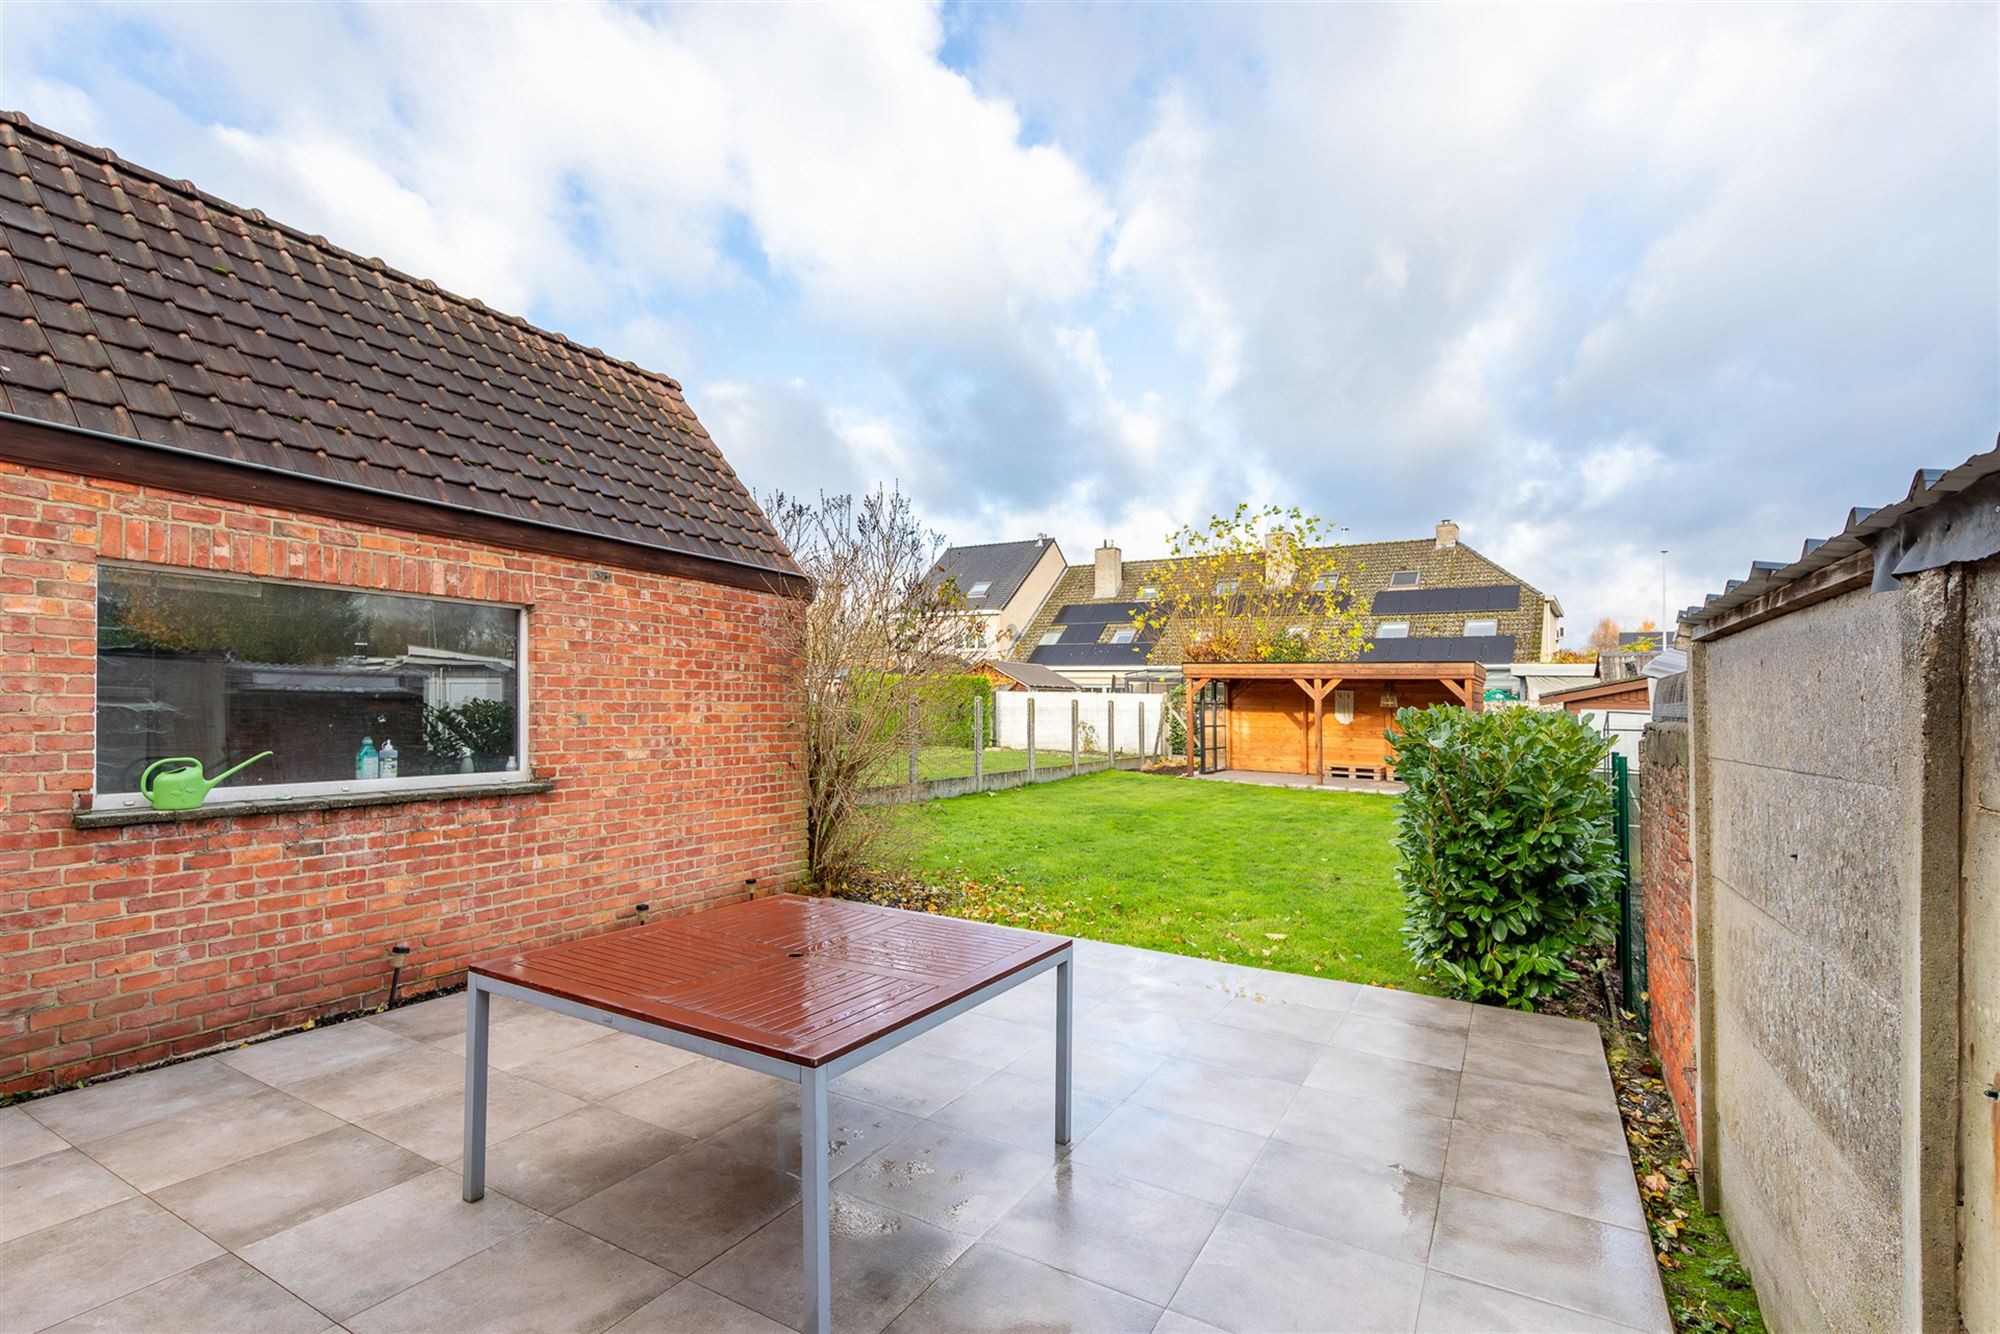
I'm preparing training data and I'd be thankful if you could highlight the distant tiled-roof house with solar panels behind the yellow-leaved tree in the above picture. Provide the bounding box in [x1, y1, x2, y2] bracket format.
[1012, 520, 1560, 698]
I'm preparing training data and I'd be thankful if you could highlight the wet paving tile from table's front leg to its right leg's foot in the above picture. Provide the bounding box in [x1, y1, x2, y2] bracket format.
[836, 1122, 1054, 1236]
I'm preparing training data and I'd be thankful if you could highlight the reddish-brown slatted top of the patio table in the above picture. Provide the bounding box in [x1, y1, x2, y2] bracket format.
[472, 894, 1070, 1066]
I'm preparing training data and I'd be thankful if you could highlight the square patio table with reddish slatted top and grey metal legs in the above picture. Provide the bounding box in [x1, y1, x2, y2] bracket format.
[464, 894, 1072, 1334]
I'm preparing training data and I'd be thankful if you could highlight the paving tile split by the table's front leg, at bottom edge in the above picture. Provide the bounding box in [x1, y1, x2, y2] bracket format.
[694, 1190, 970, 1334]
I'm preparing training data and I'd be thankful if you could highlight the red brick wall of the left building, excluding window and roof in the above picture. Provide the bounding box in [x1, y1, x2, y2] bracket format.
[0, 464, 804, 1092]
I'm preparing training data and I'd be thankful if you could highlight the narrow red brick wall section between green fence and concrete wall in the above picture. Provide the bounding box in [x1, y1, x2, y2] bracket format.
[1638, 722, 1700, 1152]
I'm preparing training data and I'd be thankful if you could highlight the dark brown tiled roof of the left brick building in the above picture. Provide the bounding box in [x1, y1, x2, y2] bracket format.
[0, 112, 798, 576]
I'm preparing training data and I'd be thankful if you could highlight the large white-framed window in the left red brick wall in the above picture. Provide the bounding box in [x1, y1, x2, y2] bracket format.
[96, 564, 528, 806]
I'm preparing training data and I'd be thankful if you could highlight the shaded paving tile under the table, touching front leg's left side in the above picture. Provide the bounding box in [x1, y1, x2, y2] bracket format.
[562, 1144, 798, 1276]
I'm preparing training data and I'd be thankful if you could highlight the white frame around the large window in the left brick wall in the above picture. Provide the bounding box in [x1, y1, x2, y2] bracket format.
[90, 560, 534, 814]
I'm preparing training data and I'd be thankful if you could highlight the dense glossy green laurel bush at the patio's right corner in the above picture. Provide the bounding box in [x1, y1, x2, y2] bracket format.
[1388, 704, 1622, 1010]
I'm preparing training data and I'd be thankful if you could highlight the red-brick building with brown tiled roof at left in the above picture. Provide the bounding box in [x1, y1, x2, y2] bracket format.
[0, 116, 806, 1094]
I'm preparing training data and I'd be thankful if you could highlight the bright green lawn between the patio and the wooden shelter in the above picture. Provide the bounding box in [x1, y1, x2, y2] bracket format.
[900, 772, 1430, 990]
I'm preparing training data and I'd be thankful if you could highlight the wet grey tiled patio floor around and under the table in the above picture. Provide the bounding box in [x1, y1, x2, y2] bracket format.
[0, 942, 1670, 1334]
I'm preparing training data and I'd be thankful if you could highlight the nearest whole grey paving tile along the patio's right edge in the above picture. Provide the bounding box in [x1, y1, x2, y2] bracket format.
[1430, 1186, 1670, 1332]
